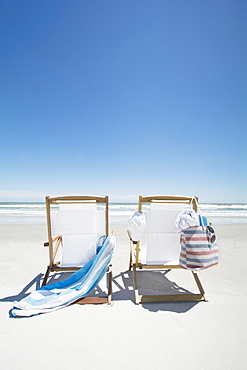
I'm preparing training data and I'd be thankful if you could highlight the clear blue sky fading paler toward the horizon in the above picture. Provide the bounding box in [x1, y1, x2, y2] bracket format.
[0, 0, 247, 202]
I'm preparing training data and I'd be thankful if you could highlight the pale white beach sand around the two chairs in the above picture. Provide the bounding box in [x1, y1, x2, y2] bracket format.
[0, 224, 247, 370]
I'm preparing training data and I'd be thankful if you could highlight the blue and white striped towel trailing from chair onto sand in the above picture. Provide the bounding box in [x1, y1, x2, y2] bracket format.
[11, 236, 116, 316]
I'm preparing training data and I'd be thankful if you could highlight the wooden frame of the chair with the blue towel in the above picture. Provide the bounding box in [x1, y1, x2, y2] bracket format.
[42, 196, 112, 304]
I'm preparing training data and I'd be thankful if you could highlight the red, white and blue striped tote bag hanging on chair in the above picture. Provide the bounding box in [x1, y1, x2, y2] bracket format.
[179, 226, 219, 270]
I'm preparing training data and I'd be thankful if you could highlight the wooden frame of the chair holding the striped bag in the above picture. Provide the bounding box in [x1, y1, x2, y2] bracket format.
[128, 196, 206, 304]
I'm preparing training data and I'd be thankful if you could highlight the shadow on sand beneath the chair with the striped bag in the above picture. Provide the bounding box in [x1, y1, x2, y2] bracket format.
[113, 270, 199, 313]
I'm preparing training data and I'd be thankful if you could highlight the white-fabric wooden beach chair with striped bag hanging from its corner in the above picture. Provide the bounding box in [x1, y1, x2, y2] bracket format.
[128, 196, 206, 304]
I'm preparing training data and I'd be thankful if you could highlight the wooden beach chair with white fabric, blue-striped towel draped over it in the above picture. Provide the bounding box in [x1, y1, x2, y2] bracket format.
[42, 196, 112, 304]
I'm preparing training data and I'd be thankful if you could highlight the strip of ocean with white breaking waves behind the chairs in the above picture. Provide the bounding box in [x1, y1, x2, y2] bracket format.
[0, 202, 247, 225]
